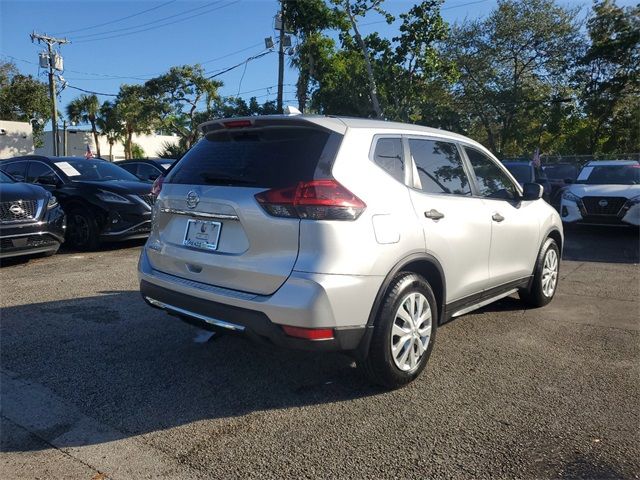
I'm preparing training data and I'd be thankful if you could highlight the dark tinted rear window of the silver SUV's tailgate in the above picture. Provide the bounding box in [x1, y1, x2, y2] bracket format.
[166, 127, 342, 188]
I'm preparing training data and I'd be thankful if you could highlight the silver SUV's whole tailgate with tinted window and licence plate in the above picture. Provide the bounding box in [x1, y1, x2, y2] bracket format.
[148, 118, 342, 295]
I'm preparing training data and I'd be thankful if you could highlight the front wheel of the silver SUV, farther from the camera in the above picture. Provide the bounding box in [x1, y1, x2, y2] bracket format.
[518, 238, 560, 307]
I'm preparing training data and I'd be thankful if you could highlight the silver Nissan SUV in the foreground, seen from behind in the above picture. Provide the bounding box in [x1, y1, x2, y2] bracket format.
[139, 115, 563, 388]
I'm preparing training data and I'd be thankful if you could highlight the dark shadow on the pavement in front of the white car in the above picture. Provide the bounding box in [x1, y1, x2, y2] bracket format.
[562, 225, 640, 263]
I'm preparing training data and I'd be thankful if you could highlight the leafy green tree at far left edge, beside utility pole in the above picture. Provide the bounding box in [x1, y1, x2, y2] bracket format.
[0, 62, 51, 147]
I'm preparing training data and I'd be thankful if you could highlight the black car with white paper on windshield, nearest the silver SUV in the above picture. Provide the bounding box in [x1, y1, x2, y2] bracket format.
[0, 155, 155, 249]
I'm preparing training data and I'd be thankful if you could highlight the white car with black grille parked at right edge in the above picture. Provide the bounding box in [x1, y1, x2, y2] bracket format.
[560, 160, 640, 226]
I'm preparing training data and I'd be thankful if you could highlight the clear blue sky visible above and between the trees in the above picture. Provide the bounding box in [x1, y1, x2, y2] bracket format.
[0, 0, 634, 128]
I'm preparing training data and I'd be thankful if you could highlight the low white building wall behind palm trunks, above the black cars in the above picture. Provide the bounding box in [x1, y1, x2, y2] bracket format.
[36, 128, 178, 160]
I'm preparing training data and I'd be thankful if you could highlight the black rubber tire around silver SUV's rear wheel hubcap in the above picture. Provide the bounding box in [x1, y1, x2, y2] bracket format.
[358, 272, 438, 389]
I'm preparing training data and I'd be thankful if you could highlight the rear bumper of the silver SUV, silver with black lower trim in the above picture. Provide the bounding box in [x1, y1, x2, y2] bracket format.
[138, 249, 383, 351]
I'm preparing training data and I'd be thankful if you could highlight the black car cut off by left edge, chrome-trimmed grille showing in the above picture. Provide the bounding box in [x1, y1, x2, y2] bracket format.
[0, 172, 66, 258]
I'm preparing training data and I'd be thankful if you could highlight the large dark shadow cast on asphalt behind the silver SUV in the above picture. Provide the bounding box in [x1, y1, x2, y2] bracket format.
[0, 291, 382, 451]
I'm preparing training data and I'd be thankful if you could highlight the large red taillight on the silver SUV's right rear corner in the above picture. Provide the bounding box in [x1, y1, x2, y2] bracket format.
[256, 180, 367, 220]
